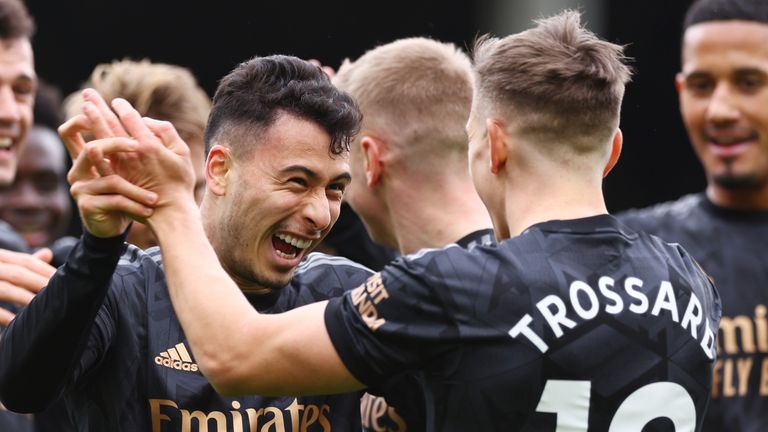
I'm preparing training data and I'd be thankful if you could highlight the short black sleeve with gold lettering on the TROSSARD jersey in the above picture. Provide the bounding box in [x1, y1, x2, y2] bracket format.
[325, 250, 458, 386]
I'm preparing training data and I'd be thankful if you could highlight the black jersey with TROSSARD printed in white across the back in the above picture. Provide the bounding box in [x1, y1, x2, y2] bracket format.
[325, 215, 720, 432]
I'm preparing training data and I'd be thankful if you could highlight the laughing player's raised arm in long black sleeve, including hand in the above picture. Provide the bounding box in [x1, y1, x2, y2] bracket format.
[0, 93, 158, 412]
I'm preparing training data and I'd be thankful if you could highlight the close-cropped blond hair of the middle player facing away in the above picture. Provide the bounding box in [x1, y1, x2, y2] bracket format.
[333, 37, 472, 159]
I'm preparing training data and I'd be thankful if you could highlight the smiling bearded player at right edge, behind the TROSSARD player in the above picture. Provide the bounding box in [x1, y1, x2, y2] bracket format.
[619, 0, 768, 432]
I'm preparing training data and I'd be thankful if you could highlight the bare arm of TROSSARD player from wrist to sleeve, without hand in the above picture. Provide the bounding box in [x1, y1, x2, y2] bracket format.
[156, 202, 362, 395]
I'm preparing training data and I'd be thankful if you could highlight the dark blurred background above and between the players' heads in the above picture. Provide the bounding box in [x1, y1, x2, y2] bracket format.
[27, 0, 704, 211]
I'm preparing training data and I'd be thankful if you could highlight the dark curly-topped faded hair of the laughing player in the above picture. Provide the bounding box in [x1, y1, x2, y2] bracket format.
[205, 55, 362, 158]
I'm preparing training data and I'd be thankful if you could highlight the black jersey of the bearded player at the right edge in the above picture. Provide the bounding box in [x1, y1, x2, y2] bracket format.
[617, 193, 768, 432]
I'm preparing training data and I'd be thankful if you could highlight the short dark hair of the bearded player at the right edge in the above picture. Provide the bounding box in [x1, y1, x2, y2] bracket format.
[683, 0, 768, 30]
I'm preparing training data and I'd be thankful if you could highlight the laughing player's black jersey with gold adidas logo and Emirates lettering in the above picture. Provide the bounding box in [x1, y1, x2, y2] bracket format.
[1, 233, 372, 432]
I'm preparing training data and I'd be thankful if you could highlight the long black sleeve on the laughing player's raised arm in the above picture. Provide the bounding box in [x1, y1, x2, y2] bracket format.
[0, 233, 125, 412]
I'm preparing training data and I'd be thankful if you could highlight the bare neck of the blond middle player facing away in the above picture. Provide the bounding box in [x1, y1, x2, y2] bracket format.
[388, 181, 492, 254]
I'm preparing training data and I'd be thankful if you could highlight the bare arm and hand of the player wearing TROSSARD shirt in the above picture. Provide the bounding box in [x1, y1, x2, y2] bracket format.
[106, 100, 362, 395]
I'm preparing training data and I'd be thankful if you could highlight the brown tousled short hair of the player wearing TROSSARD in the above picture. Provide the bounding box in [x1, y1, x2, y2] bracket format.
[473, 10, 632, 154]
